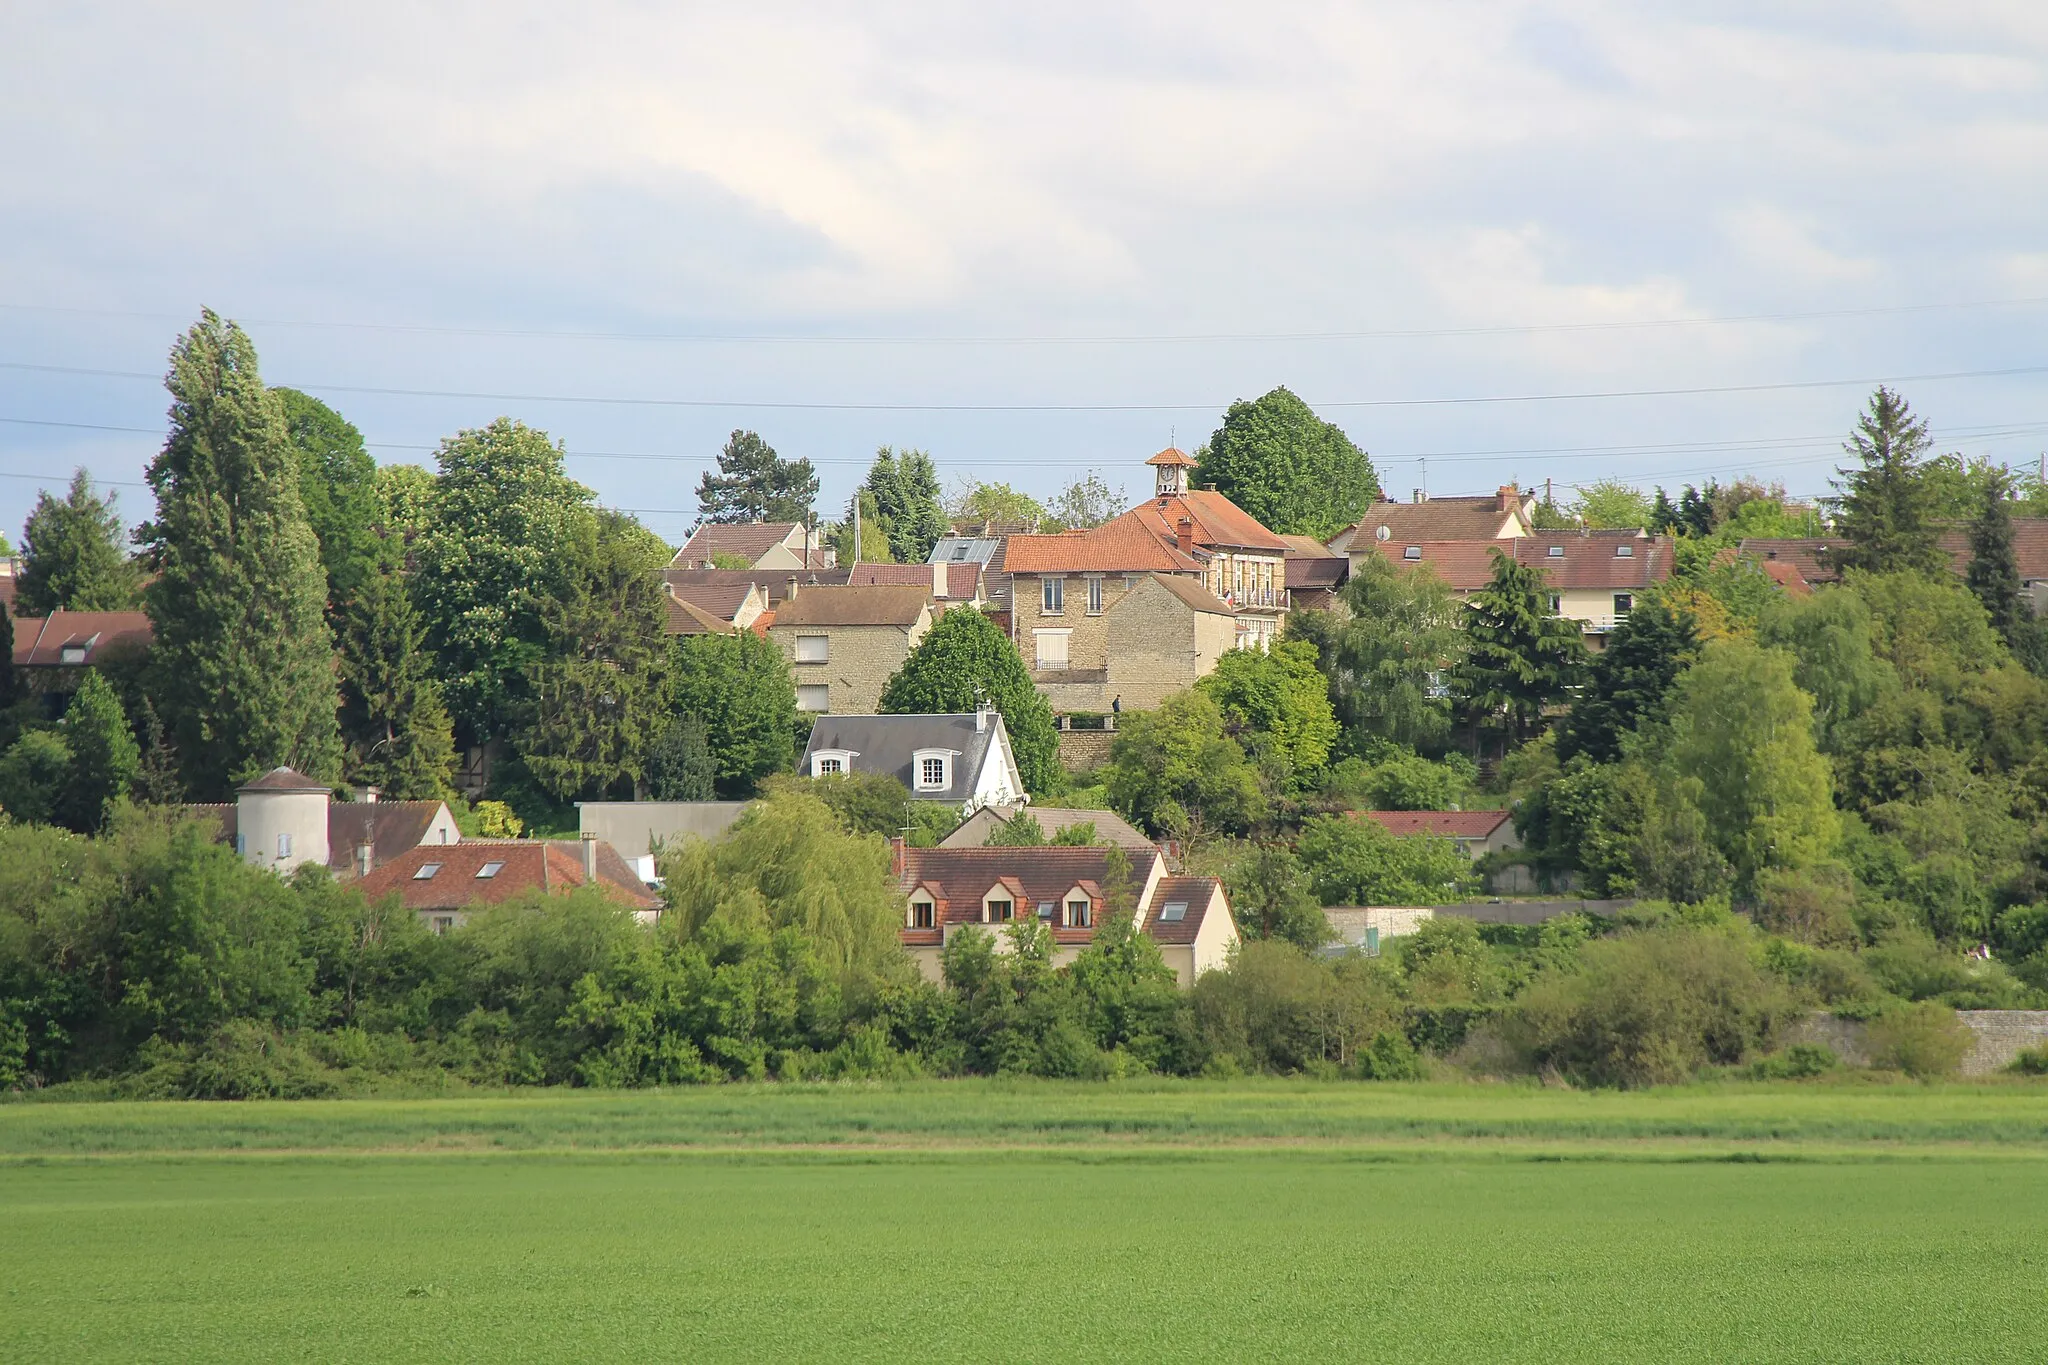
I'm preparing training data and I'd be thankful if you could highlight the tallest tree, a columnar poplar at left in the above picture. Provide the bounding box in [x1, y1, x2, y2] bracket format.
[143, 311, 340, 800]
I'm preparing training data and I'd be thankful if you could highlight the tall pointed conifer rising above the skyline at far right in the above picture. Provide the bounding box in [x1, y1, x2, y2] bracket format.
[1833, 387, 1948, 573]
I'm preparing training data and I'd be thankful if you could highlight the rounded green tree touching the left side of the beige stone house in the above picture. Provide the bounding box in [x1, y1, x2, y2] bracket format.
[668, 630, 799, 800]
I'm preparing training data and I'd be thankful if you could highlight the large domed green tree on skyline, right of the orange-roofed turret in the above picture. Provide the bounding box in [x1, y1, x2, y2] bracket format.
[1194, 389, 1380, 540]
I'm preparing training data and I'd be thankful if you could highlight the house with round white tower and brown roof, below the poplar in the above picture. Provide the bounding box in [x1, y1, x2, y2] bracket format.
[186, 767, 463, 880]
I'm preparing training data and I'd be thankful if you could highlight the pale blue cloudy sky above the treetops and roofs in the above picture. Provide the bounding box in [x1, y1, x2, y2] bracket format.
[0, 0, 2048, 542]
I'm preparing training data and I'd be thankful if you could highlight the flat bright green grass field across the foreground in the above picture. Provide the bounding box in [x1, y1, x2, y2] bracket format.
[0, 1083, 2048, 1363]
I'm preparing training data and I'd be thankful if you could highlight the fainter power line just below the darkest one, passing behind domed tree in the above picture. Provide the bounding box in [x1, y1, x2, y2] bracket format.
[0, 360, 2048, 413]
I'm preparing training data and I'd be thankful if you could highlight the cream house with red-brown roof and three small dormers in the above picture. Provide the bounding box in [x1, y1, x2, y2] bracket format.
[895, 841, 1237, 986]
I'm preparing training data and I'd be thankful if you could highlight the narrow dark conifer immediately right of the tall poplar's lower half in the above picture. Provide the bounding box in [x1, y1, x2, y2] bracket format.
[342, 569, 455, 800]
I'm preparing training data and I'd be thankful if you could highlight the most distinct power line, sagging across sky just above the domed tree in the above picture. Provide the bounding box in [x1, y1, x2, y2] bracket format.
[0, 297, 2048, 346]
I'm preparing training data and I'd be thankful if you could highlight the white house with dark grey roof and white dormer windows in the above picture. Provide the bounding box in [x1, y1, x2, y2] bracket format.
[797, 708, 1030, 814]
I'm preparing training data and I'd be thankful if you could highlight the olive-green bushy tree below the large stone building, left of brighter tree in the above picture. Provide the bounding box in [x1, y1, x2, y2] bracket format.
[1104, 692, 1266, 835]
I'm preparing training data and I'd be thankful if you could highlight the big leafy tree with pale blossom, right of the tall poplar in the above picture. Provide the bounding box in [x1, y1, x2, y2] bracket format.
[410, 417, 592, 743]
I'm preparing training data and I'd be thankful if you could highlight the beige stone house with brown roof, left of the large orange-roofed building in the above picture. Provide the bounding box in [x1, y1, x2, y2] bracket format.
[768, 579, 932, 716]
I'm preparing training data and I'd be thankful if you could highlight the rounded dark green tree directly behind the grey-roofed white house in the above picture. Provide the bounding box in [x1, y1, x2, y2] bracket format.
[881, 608, 1061, 796]
